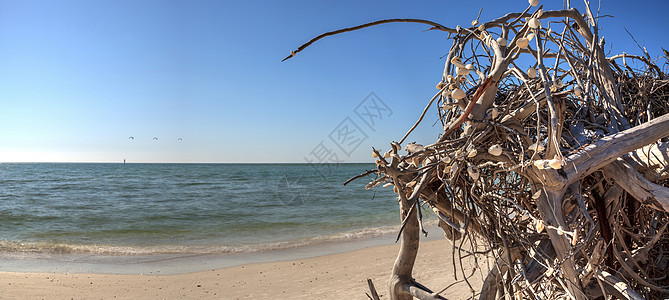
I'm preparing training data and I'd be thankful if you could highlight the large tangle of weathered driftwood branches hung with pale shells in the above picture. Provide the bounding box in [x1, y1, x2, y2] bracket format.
[286, 1, 669, 299]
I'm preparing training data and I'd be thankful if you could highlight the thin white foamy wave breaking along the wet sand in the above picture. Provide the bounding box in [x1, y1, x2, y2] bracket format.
[0, 226, 408, 256]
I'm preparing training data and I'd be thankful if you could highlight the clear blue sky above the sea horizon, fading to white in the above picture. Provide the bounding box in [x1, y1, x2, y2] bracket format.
[0, 0, 669, 163]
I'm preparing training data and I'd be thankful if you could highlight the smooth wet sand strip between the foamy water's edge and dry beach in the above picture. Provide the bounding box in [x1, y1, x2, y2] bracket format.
[0, 224, 442, 275]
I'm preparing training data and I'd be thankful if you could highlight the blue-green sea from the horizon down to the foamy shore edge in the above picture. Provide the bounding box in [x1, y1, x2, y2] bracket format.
[0, 163, 398, 255]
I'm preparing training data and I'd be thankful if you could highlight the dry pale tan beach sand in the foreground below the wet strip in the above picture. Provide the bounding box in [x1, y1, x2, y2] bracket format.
[0, 240, 485, 299]
